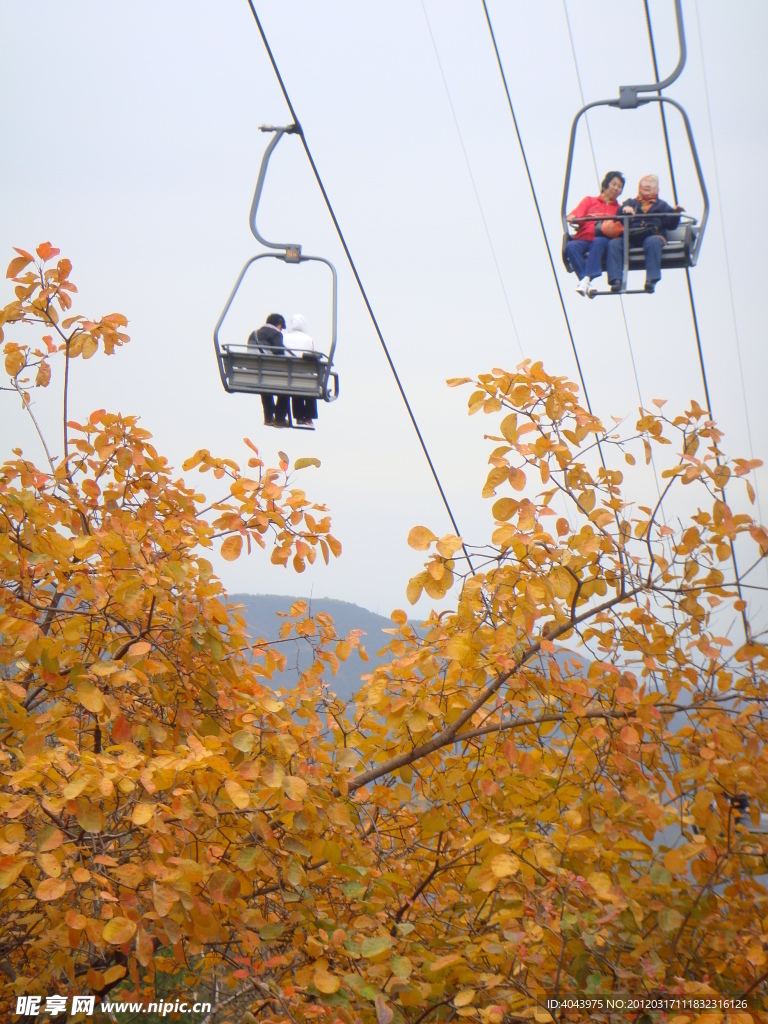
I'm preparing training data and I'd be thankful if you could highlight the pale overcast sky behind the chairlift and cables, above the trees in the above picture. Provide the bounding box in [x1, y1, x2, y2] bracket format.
[0, 0, 768, 627]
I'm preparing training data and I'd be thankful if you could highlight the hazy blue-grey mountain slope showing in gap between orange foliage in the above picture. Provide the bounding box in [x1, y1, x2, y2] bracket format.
[229, 594, 393, 700]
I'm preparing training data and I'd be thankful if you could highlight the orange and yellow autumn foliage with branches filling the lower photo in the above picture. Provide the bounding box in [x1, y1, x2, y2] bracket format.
[0, 245, 768, 1024]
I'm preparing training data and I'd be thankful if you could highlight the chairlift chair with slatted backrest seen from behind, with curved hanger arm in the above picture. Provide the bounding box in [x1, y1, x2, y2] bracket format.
[213, 125, 339, 429]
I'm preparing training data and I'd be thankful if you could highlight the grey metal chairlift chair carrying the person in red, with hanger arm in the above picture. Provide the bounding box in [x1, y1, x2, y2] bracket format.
[560, 0, 710, 296]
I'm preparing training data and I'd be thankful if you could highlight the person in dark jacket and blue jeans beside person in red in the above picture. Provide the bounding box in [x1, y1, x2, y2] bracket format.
[605, 174, 684, 292]
